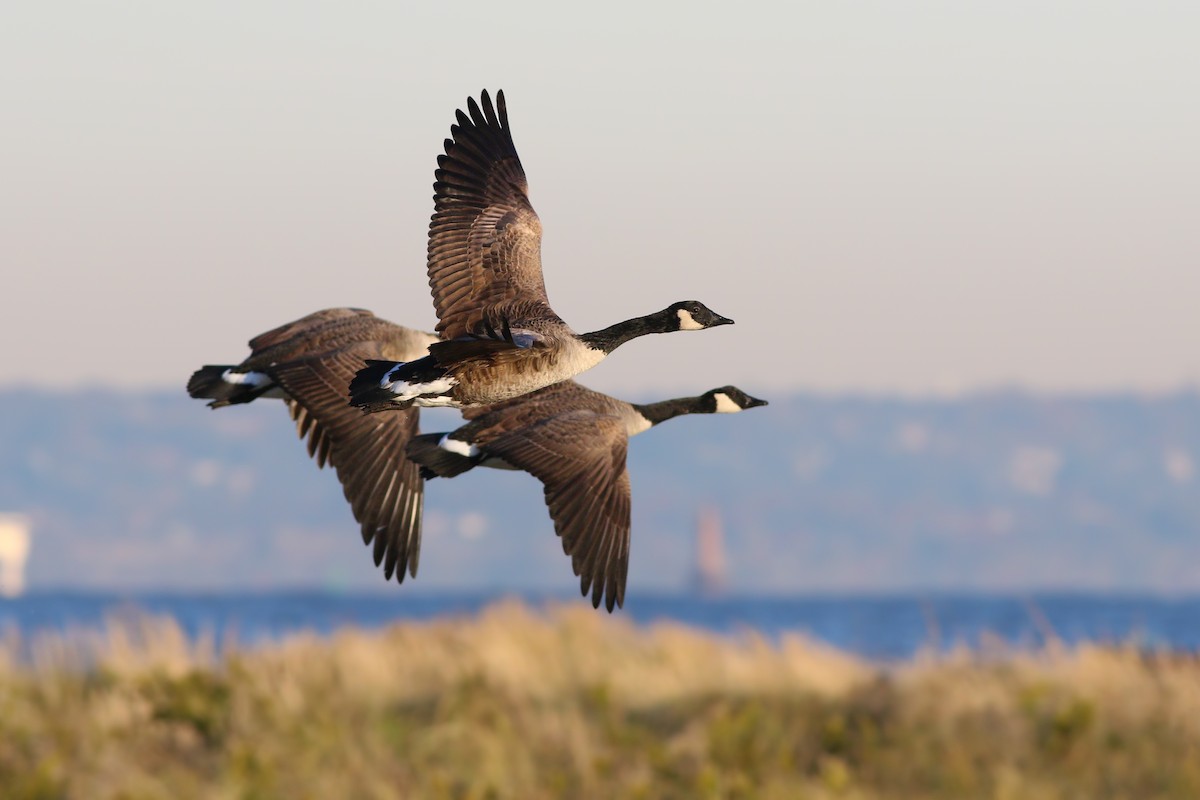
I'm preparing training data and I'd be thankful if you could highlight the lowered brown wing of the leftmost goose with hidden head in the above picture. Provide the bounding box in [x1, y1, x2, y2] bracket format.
[271, 342, 425, 582]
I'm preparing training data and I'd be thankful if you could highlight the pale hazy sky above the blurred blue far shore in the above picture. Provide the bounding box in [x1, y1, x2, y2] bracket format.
[0, 0, 1200, 395]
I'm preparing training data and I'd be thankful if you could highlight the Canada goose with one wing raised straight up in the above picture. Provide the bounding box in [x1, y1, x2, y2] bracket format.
[350, 91, 733, 411]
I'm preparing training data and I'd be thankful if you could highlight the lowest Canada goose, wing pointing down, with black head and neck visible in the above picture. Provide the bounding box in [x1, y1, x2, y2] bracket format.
[408, 380, 767, 612]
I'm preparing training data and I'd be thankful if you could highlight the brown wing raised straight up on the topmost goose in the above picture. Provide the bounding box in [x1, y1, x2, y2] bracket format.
[427, 91, 558, 339]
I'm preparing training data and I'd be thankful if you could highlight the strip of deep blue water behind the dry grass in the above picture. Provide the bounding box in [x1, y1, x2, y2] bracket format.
[0, 591, 1200, 660]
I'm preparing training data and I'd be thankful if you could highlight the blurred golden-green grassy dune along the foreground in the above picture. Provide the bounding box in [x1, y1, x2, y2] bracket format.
[0, 604, 1200, 800]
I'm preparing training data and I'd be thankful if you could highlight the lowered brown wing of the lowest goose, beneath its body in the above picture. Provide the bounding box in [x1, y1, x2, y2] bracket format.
[487, 410, 630, 612]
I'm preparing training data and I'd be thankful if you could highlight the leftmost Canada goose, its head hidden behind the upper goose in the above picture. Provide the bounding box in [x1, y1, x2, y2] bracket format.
[187, 308, 437, 582]
